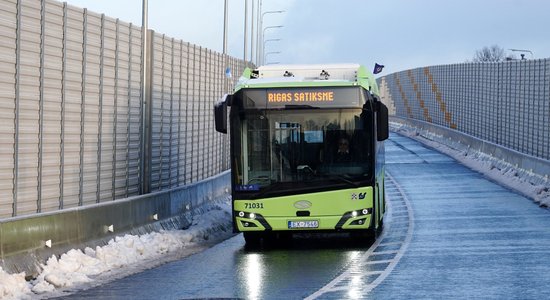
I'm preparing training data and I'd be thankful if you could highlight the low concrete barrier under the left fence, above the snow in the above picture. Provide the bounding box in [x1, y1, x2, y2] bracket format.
[0, 171, 231, 277]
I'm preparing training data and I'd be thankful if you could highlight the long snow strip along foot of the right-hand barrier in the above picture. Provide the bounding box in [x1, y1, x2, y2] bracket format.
[390, 122, 550, 207]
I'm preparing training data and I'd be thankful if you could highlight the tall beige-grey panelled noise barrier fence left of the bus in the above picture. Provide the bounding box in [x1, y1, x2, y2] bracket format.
[0, 0, 251, 219]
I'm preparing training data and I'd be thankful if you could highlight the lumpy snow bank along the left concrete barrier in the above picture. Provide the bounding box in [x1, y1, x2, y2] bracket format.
[0, 200, 232, 299]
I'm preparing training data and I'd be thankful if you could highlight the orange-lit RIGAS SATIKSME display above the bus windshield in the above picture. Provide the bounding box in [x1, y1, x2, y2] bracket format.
[242, 87, 365, 109]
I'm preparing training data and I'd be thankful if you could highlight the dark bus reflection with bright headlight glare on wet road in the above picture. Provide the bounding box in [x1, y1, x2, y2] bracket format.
[235, 234, 373, 299]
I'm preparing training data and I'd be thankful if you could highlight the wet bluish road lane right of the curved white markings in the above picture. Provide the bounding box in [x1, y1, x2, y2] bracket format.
[369, 135, 550, 299]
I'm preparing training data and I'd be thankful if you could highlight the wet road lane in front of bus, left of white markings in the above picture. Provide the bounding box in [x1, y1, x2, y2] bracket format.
[58, 235, 374, 299]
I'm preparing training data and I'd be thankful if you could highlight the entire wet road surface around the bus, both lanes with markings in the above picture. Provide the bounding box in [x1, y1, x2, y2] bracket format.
[58, 134, 550, 299]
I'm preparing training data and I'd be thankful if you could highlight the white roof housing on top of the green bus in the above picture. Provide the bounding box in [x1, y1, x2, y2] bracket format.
[235, 64, 378, 95]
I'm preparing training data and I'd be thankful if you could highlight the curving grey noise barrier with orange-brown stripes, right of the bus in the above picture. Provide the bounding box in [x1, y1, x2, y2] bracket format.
[377, 59, 550, 160]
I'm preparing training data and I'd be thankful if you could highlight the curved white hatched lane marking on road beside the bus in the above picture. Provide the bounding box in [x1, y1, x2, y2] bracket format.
[305, 172, 414, 300]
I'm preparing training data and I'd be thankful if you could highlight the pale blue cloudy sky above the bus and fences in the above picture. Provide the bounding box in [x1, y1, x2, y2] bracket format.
[67, 0, 550, 75]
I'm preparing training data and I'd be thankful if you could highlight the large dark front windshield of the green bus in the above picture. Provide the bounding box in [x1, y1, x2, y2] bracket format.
[232, 108, 374, 198]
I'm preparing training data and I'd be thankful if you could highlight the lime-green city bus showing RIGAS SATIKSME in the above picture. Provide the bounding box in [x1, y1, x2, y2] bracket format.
[214, 64, 389, 244]
